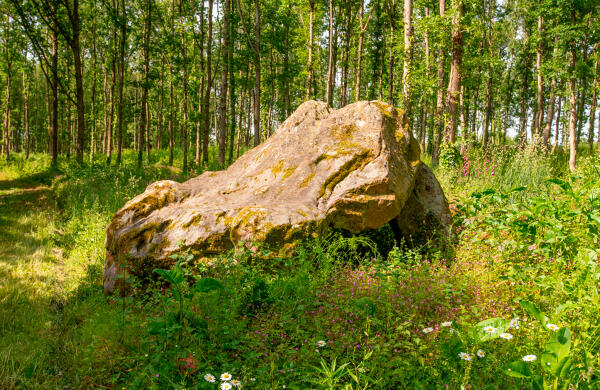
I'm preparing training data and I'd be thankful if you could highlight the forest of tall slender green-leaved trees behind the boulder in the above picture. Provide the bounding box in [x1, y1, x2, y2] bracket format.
[0, 0, 600, 171]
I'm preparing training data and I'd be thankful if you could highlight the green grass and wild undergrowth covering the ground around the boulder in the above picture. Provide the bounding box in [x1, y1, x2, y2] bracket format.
[0, 148, 600, 389]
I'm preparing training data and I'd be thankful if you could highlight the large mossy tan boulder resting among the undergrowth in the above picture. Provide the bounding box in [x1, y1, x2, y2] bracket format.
[104, 101, 450, 293]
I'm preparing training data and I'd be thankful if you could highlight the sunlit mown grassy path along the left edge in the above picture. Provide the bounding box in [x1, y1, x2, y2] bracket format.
[0, 168, 65, 388]
